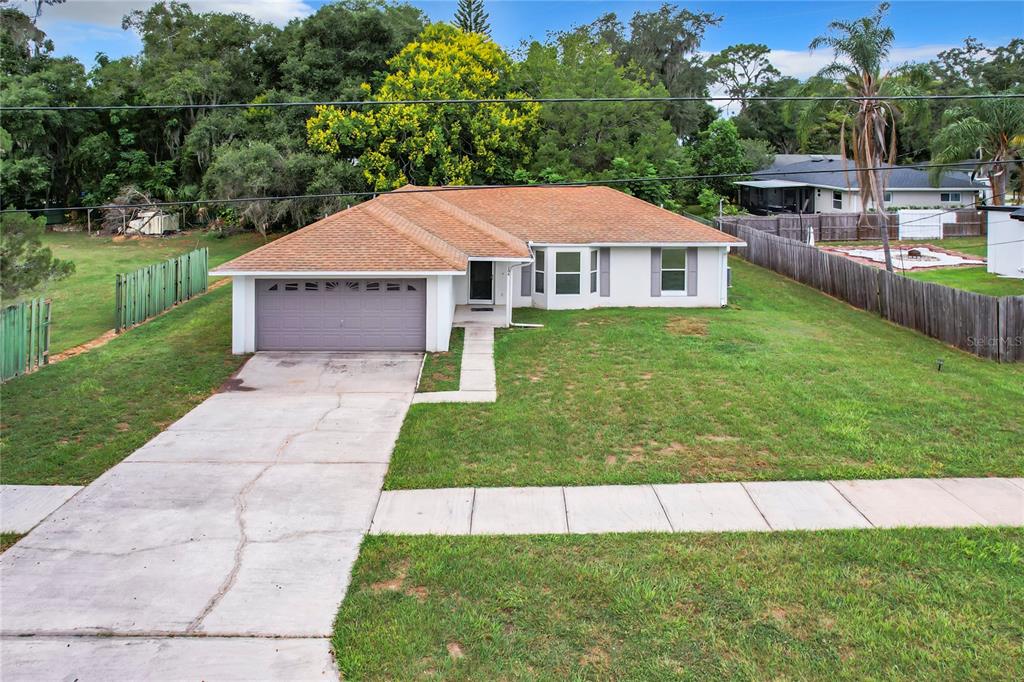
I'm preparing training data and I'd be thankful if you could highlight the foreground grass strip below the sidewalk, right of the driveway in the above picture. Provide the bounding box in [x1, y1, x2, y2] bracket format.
[334, 528, 1024, 680]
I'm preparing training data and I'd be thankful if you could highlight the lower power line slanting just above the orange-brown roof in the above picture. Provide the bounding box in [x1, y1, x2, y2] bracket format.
[0, 160, 1015, 213]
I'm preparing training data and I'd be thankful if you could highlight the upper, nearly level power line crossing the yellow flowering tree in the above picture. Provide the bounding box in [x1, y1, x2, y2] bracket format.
[0, 93, 1024, 113]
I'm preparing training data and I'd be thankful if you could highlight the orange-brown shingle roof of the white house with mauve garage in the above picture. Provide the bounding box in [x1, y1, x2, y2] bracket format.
[214, 185, 741, 273]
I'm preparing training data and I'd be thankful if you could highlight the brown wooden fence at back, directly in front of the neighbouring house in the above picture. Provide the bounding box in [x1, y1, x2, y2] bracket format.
[725, 209, 985, 242]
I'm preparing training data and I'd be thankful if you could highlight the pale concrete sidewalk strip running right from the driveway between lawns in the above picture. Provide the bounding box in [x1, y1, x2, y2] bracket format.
[371, 478, 1024, 536]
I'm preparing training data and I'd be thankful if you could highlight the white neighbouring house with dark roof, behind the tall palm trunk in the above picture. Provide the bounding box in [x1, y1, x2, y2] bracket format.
[733, 154, 986, 214]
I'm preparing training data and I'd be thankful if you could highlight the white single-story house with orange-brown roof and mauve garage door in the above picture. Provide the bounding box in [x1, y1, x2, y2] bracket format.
[212, 185, 743, 353]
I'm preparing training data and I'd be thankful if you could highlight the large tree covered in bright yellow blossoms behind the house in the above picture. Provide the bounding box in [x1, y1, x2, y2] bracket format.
[306, 24, 540, 190]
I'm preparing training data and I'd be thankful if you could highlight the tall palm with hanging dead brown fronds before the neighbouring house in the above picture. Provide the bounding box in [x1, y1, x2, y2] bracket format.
[810, 2, 902, 272]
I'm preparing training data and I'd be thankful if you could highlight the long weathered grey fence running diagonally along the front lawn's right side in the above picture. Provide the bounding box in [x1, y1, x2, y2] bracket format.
[720, 220, 1024, 363]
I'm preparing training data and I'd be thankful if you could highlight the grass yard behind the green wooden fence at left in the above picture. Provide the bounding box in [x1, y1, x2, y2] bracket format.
[31, 232, 264, 354]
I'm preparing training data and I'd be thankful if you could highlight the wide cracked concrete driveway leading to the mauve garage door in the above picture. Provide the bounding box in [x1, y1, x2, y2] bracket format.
[0, 353, 421, 680]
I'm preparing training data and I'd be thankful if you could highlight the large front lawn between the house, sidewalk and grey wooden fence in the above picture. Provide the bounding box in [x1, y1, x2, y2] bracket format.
[386, 259, 1024, 488]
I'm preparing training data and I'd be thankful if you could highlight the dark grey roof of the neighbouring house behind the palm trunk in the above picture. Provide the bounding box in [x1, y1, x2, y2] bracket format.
[734, 155, 984, 190]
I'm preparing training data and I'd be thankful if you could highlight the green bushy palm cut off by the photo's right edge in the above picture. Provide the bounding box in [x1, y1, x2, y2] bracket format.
[931, 99, 1024, 206]
